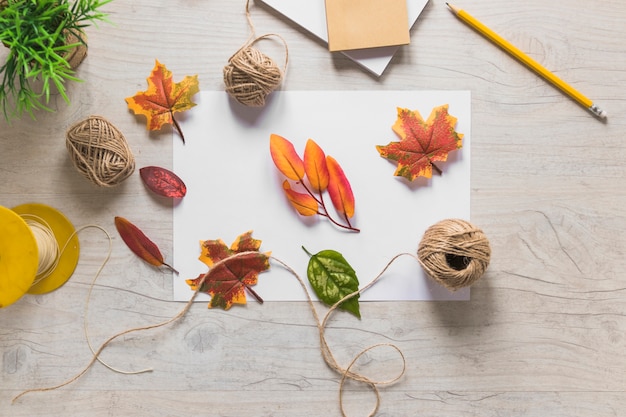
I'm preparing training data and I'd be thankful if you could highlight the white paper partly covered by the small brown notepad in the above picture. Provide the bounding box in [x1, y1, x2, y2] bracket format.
[260, 0, 428, 76]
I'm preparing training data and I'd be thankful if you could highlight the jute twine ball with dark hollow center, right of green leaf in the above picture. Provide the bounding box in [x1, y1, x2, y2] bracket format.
[417, 219, 491, 291]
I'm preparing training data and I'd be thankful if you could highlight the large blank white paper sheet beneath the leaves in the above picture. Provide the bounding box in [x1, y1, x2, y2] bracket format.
[173, 91, 471, 301]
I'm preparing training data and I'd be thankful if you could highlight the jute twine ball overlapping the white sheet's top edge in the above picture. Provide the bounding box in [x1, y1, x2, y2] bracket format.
[224, 38, 283, 107]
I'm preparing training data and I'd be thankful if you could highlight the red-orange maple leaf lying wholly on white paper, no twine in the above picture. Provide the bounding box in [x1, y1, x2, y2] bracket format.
[376, 104, 463, 181]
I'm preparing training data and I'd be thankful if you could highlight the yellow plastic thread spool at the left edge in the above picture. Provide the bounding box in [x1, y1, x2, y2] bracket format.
[0, 203, 80, 308]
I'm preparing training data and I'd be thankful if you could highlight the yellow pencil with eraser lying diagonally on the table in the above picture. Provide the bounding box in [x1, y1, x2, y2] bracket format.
[446, 3, 607, 119]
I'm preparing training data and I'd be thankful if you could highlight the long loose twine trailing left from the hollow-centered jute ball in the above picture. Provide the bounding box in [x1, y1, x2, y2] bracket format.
[12, 250, 416, 417]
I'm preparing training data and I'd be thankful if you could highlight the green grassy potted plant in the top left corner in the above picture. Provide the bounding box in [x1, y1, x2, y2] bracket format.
[0, 0, 112, 120]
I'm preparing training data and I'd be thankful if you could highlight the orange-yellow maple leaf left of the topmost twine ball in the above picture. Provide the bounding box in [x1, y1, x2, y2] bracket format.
[126, 60, 200, 143]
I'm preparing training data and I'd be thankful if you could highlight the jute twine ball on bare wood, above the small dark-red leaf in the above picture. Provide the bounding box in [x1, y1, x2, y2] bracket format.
[65, 116, 135, 187]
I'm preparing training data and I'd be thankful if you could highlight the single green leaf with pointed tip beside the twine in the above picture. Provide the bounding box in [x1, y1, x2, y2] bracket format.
[302, 247, 361, 318]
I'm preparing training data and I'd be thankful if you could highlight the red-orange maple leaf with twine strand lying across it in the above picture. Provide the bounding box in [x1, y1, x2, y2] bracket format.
[185, 231, 270, 310]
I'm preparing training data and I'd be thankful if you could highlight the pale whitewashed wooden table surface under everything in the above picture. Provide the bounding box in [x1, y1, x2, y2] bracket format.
[0, 0, 626, 417]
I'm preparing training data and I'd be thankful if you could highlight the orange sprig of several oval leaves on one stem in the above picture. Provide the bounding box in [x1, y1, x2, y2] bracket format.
[270, 134, 359, 232]
